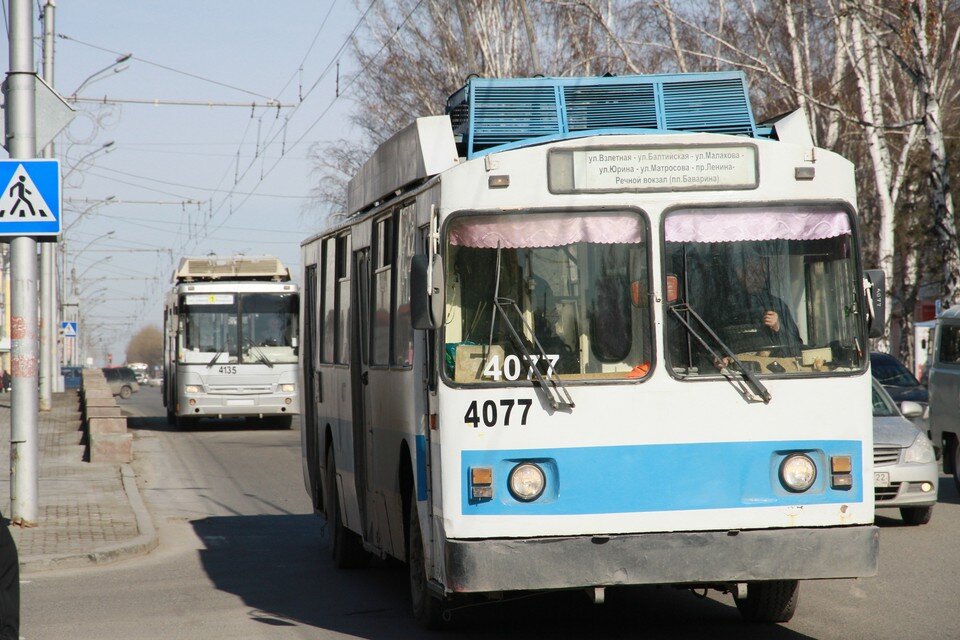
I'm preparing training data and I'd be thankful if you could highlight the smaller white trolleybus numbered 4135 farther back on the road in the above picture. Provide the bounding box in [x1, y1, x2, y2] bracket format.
[163, 256, 300, 427]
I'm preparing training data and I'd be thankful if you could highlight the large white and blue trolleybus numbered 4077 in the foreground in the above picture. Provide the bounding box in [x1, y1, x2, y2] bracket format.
[300, 72, 883, 625]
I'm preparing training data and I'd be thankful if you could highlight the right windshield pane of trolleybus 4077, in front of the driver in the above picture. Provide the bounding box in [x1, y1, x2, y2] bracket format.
[664, 207, 866, 377]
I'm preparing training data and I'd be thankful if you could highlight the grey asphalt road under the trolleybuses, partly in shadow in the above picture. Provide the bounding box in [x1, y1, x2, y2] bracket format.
[16, 387, 960, 640]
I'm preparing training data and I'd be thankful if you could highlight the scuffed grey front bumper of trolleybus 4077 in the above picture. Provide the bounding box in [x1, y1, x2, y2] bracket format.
[444, 525, 880, 593]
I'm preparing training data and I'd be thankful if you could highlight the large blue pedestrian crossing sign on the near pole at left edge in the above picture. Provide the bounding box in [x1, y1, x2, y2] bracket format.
[0, 160, 60, 236]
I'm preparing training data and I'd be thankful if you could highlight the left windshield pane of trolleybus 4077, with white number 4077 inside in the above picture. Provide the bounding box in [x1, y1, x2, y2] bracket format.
[444, 212, 652, 384]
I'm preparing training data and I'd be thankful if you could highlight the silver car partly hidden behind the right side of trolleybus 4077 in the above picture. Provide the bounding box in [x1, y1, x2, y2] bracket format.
[873, 380, 940, 525]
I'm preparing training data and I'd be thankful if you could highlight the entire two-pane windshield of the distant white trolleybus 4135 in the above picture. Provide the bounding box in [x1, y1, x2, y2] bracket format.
[180, 293, 299, 366]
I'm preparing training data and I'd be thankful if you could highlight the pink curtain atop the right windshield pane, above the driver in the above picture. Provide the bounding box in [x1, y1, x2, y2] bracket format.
[664, 209, 850, 242]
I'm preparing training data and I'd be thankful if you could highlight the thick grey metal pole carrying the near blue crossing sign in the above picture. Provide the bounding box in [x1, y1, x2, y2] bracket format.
[6, 0, 40, 527]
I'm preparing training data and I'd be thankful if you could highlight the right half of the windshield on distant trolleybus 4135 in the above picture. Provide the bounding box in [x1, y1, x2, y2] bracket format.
[240, 293, 299, 363]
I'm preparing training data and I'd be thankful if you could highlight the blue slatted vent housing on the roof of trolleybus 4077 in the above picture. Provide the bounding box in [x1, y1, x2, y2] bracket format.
[447, 71, 758, 158]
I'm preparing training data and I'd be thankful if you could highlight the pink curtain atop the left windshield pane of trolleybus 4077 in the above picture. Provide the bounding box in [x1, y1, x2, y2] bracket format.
[449, 213, 644, 249]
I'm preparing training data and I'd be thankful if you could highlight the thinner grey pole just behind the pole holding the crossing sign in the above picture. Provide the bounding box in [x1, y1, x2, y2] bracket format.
[40, 0, 60, 411]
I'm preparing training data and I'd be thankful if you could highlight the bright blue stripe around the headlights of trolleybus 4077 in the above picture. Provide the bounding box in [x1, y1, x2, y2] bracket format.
[461, 440, 872, 515]
